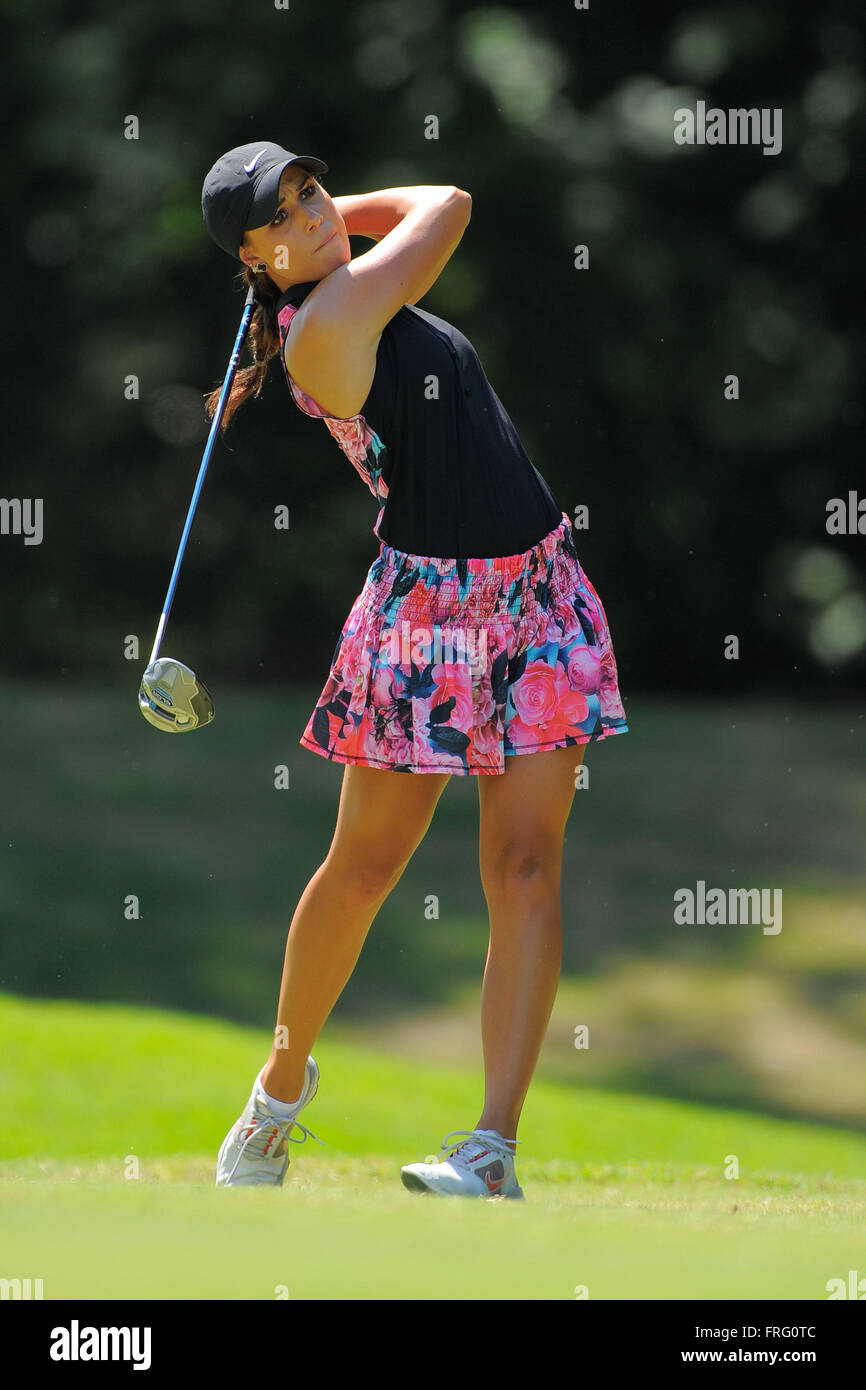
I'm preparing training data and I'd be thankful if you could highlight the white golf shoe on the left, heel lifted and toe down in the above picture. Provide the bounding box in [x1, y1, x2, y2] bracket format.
[215, 1056, 324, 1187]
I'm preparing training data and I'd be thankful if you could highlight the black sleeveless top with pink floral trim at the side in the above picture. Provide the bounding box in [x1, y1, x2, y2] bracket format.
[277, 279, 562, 559]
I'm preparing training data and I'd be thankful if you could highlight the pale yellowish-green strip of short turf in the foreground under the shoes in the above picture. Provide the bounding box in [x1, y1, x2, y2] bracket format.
[0, 1155, 866, 1300]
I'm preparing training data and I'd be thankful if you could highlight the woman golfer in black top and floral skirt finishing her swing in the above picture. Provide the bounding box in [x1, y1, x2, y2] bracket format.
[202, 140, 628, 1198]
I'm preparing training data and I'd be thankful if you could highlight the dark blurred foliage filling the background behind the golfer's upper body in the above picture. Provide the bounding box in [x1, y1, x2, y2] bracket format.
[0, 0, 866, 694]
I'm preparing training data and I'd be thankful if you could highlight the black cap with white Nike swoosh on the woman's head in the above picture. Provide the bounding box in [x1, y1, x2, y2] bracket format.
[202, 140, 328, 256]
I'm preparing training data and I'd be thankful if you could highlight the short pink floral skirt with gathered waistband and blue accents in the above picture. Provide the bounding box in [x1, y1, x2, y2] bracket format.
[299, 512, 628, 776]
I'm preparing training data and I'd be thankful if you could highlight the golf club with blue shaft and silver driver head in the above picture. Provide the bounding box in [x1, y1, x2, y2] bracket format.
[139, 286, 256, 734]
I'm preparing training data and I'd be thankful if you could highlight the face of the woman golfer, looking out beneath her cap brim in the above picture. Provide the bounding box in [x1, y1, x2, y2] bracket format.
[238, 164, 352, 289]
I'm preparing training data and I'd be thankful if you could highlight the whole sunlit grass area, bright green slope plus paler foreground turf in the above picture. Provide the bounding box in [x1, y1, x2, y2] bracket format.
[0, 995, 866, 1300]
